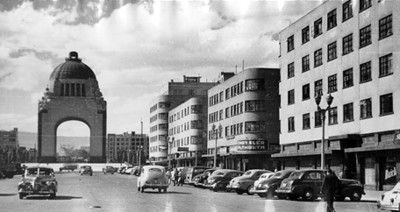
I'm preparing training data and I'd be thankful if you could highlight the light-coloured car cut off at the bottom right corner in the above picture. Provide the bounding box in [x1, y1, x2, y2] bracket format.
[377, 181, 400, 211]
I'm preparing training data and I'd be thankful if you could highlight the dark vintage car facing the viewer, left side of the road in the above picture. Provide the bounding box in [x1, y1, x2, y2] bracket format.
[18, 166, 57, 199]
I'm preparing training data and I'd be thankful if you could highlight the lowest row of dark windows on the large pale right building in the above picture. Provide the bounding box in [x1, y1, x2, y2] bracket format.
[288, 93, 394, 132]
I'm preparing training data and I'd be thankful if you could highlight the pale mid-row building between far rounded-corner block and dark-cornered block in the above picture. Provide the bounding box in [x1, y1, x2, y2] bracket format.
[168, 96, 208, 166]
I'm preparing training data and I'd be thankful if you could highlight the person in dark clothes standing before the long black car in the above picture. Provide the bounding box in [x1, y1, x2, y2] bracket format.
[322, 169, 341, 212]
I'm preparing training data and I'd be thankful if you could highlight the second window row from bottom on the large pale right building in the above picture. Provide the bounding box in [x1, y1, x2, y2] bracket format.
[288, 54, 393, 105]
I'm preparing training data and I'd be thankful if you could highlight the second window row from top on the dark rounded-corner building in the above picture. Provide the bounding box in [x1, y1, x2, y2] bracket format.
[208, 100, 266, 123]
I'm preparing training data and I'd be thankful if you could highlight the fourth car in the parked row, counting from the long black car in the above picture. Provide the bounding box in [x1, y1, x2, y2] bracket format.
[204, 169, 243, 192]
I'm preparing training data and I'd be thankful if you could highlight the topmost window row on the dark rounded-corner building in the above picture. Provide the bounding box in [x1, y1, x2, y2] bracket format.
[208, 79, 265, 106]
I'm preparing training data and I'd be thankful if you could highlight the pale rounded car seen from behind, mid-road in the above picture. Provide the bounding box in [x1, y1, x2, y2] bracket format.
[137, 165, 169, 193]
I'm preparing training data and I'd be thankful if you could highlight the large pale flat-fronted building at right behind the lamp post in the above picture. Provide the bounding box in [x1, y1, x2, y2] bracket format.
[273, 0, 400, 190]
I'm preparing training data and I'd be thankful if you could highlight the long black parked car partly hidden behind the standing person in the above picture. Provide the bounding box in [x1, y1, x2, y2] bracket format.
[276, 169, 365, 201]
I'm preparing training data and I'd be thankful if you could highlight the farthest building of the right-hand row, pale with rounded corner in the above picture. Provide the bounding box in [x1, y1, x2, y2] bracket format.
[149, 76, 216, 163]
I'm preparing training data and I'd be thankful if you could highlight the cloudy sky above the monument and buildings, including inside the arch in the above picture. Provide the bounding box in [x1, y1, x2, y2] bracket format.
[0, 0, 322, 146]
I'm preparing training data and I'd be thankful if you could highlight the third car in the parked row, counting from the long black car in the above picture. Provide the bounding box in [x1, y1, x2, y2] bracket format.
[226, 169, 272, 195]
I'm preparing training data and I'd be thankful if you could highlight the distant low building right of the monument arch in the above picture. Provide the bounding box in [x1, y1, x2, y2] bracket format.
[106, 132, 149, 165]
